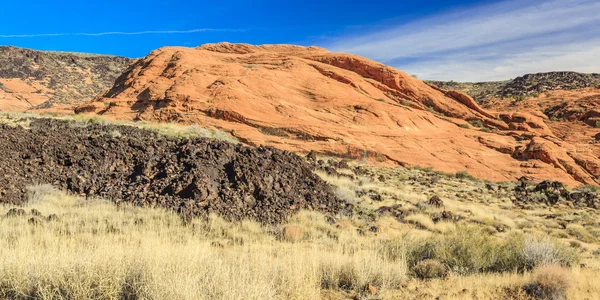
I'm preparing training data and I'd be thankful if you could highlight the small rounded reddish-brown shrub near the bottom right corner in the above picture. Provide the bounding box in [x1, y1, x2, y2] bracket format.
[525, 266, 571, 300]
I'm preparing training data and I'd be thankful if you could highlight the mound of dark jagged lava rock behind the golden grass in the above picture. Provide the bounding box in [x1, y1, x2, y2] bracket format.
[0, 119, 346, 224]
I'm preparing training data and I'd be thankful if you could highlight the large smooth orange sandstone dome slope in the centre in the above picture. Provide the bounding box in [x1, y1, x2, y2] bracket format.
[76, 43, 600, 185]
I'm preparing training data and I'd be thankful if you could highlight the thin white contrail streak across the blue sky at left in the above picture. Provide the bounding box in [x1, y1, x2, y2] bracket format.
[0, 28, 248, 38]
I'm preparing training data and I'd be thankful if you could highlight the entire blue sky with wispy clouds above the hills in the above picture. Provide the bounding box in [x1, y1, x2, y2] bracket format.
[0, 0, 600, 81]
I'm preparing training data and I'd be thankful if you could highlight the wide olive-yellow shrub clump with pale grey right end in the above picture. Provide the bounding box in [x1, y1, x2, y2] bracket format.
[406, 225, 578, 275]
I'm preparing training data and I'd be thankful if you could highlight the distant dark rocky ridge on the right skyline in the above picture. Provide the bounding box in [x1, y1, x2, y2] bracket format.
[427, 72, 600, 102]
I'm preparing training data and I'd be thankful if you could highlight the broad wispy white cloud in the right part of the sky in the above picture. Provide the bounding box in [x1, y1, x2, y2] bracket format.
[328, 0, 600, 81]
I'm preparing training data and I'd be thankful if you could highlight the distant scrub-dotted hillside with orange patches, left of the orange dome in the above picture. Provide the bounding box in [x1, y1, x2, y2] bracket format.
[0, 47, 131, 111]
